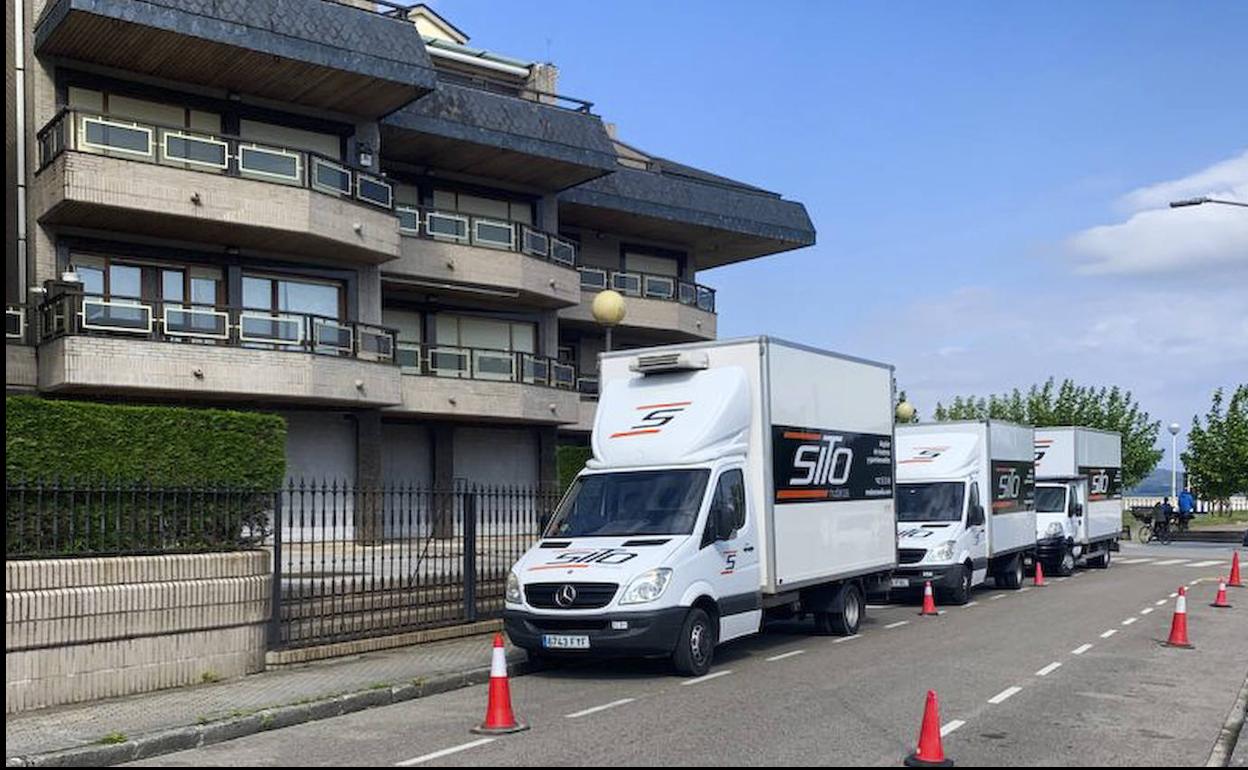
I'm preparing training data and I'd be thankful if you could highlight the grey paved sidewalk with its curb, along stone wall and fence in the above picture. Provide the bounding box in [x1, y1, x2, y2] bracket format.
[5, 626, 524, 766]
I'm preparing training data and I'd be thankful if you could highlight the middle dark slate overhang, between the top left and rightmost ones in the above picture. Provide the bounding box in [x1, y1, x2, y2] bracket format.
[382, 82, 617, 192]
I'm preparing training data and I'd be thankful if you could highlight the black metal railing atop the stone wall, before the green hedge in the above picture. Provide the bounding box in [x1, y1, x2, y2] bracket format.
[5, 474, 270, 559]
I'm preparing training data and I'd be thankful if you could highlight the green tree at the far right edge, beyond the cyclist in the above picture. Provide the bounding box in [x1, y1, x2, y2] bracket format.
[1183, 384, 1248, 509]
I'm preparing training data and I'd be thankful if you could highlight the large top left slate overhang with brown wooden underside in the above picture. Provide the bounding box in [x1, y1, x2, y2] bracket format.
[35, 0, 437, 119]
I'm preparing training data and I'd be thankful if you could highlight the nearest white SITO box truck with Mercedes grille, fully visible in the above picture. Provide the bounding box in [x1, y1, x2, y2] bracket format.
[503, 337, 896, 675]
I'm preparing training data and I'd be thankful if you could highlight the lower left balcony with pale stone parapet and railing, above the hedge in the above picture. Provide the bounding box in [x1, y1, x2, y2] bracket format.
[37, 295, 402, 407]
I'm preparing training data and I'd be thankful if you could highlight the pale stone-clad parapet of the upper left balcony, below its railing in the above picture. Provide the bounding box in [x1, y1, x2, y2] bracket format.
[32, 152, 399, 265]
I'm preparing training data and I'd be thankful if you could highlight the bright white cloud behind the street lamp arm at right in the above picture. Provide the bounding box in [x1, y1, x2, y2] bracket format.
[1067, 151, 1248, 276]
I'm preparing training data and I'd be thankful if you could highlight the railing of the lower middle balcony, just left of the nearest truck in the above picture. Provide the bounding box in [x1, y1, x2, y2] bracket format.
[397, 341, 577, 391]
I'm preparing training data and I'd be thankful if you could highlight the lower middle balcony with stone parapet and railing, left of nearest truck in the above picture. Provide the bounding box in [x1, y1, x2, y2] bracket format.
[388, 342, 580, 426]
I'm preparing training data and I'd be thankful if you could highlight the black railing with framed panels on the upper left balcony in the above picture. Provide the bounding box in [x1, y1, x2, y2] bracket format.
[39, 110, 394, 210]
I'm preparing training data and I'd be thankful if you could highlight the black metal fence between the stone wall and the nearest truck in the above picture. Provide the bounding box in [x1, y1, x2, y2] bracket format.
[270, 483, 558, 649]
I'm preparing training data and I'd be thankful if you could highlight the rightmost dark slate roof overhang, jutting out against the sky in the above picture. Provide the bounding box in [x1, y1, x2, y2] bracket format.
[559, 167, 815, 270]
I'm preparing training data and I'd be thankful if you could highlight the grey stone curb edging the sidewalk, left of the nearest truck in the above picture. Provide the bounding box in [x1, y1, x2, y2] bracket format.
[5, 658, 540, 768]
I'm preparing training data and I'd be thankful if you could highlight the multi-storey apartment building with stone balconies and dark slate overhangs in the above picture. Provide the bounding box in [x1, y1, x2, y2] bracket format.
[5, 0, 815, 485]
